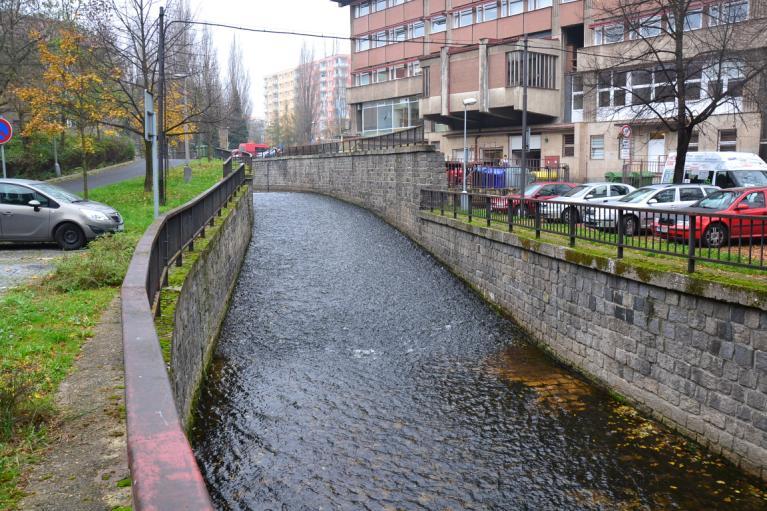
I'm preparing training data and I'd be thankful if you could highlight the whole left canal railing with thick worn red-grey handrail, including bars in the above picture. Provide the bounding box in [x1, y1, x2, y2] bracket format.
[120, 165, 245, 510]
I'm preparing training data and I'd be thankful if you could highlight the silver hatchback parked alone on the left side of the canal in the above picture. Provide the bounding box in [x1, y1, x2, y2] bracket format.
[0, 179, 125, 250]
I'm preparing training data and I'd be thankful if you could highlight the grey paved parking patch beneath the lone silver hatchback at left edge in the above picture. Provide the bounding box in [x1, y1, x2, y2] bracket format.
[0, 243, 63, 296]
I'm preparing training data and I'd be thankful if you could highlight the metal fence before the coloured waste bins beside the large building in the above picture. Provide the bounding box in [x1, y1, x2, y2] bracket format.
[445, 160, 570, 191]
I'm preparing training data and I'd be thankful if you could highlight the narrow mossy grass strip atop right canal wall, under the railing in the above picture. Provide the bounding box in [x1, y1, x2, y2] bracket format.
[424, 209, 767, 300]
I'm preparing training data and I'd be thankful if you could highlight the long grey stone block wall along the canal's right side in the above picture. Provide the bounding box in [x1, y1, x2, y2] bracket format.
[254, 148, 767, 480]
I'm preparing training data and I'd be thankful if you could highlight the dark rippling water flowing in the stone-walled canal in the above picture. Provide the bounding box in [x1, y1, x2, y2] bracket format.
[193, 194, 767, 510]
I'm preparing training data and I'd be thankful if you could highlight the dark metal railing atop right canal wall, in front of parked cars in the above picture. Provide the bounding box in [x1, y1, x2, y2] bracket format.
[420, 190, 767, 273]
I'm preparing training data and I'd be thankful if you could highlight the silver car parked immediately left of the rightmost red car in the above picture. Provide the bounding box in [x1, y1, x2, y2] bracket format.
[584, 184, 719, 236]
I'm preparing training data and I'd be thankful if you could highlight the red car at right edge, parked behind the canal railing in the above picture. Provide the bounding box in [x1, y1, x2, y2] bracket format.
[655, 187, 767, 248]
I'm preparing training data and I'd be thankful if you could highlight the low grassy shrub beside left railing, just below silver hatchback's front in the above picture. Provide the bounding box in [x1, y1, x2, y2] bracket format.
[47, 233, 136, 291]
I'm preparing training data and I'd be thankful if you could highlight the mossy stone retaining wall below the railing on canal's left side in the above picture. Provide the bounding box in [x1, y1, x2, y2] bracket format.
[169, 191, 253, 429]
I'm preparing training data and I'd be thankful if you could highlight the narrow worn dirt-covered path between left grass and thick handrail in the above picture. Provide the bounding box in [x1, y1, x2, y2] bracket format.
[20, 298, 131, 511]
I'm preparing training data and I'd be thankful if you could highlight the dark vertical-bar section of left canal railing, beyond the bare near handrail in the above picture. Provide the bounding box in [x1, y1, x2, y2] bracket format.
[146, 164, 245, 314]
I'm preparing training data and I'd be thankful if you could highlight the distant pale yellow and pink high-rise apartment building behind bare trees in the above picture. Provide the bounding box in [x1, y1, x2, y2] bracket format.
[264, 55, 351, 139]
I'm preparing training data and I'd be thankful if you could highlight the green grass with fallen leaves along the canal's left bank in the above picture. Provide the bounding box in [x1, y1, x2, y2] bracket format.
[0, 161, 221, 509]
